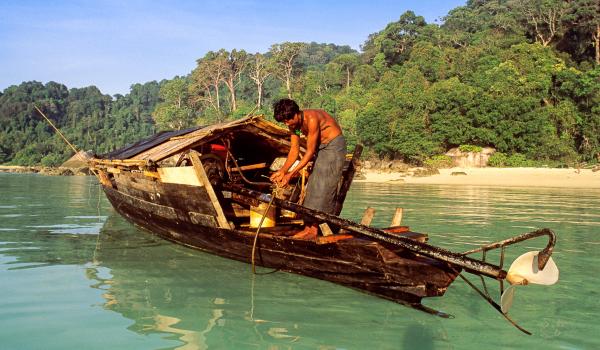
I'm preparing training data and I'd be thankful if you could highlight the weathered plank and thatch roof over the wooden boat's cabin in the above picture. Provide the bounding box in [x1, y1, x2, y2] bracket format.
[99, 115, 289, 162]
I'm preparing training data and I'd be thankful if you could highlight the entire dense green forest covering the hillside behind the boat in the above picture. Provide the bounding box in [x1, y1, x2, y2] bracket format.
[0, 0, 600, 165]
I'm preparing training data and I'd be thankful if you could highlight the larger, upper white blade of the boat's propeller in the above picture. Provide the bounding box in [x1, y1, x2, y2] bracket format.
[503, 251, 558, 286]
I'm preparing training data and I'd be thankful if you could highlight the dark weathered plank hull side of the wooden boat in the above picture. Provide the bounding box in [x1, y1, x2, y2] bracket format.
[103, 176, 460, 306]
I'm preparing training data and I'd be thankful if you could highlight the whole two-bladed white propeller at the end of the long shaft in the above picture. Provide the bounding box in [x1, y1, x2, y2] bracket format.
[500, 251, 559, 314]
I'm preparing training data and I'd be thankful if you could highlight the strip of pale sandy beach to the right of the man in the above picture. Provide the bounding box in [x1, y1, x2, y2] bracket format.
[354, 168, 600, 189]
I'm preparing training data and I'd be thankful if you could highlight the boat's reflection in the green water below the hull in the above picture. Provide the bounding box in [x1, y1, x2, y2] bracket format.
[86, 215, 446, 349]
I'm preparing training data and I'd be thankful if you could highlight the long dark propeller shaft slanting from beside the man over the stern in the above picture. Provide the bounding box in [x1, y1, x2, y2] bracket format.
[223, 184, 506, 280]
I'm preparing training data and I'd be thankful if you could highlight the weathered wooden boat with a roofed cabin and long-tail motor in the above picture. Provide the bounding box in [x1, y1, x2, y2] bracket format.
[90, 116, 554, 322]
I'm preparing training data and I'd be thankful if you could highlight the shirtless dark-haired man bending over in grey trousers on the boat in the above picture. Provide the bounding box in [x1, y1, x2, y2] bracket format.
[271, 99, 346, 239]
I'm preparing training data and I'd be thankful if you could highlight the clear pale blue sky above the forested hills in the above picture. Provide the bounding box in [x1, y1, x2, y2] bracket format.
[0, 0, 466, 95]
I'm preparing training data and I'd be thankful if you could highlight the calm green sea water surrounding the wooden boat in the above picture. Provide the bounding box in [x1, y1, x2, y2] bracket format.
[0, 174, 600, 350]
